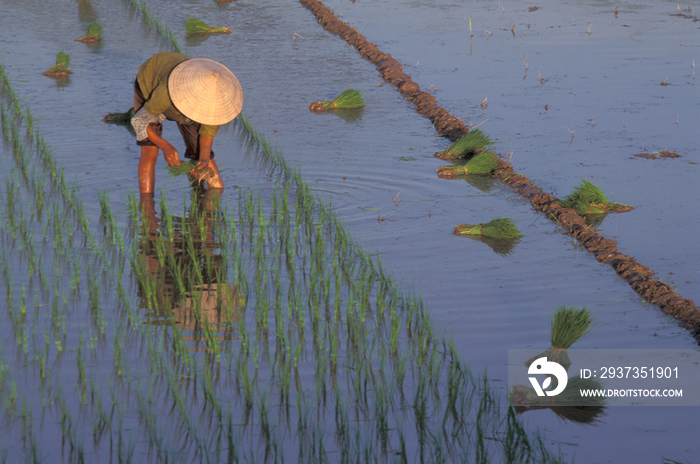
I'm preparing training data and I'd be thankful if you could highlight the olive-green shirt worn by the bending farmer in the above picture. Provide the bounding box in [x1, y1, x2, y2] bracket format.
[136, 52, 219, 138]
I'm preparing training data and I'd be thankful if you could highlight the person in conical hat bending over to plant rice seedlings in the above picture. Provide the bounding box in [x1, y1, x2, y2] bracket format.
[131, 52, 243, 193]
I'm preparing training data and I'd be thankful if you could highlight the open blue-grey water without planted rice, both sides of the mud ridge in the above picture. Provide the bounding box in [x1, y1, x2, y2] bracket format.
[0, 0, 700, 462]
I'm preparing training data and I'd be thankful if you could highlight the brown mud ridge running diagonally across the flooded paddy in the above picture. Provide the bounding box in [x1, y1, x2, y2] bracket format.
[299, 0, 700, 341]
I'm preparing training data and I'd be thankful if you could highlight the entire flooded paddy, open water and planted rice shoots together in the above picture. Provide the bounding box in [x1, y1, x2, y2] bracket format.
[0, 0, 700, 462]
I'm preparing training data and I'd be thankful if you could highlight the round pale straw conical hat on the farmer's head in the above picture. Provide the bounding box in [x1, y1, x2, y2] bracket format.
[168, 58, 243, 126]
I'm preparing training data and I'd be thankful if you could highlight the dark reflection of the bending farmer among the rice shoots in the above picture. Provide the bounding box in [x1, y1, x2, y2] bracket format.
[137, 189, 245, 350]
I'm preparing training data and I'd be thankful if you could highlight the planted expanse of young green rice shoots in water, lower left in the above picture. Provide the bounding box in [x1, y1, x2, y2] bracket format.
[0, 4, 568, 462]
